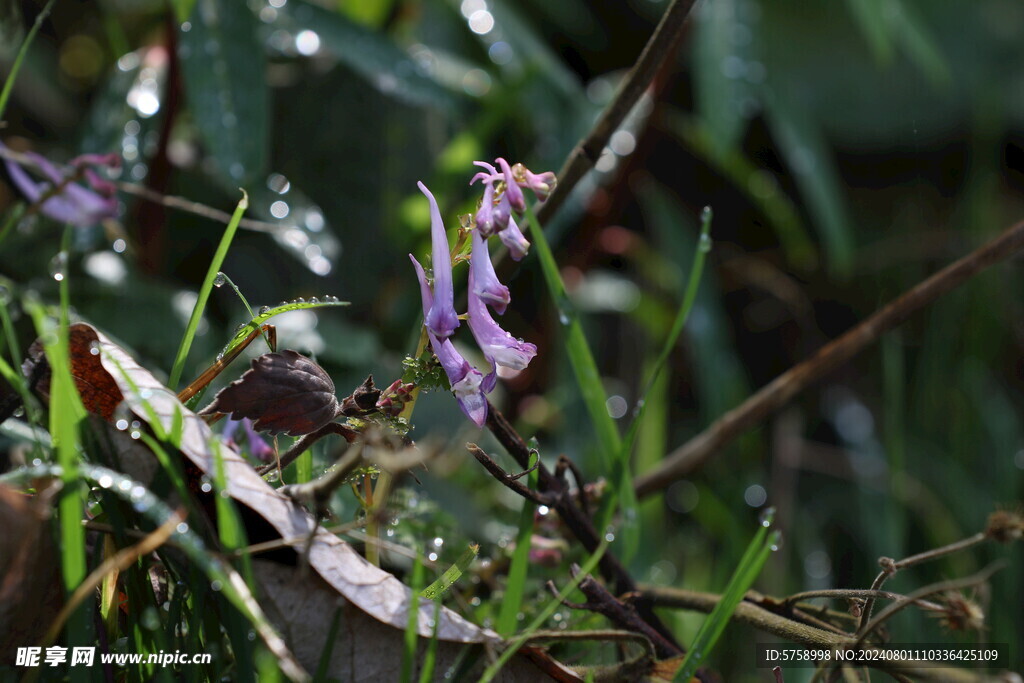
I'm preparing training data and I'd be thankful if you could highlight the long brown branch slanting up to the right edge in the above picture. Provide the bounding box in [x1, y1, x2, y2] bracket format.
[636, 216, 1024, 497]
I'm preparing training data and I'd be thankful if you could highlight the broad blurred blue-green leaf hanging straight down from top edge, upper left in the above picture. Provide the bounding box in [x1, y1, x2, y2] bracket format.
[178, 0, 270, 187]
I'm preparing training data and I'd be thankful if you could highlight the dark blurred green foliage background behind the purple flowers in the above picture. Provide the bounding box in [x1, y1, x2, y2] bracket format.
[0, 0, 1024, 681]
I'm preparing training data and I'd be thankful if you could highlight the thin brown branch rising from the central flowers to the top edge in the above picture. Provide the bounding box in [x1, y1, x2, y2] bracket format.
[537, 0, 695, 225]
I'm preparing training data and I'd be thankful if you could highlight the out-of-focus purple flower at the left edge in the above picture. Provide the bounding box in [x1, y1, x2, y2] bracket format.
[0, 144, 121, 227]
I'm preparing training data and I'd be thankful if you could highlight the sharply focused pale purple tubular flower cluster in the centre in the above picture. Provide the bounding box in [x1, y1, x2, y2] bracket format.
[409, 159, 555, 426]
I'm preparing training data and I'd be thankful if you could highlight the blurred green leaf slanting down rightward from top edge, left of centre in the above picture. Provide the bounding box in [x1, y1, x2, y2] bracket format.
[286, 0, 456, 109]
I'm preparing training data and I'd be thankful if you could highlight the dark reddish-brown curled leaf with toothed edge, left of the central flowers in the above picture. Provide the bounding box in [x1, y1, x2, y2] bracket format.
[204, 349, 338, 436]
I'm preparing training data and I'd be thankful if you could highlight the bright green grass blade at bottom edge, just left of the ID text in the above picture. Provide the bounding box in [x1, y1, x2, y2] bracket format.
[672, 508, 779, 681]
